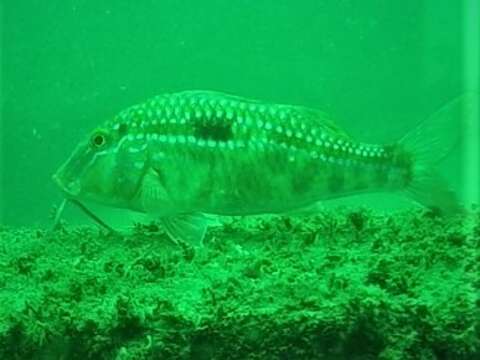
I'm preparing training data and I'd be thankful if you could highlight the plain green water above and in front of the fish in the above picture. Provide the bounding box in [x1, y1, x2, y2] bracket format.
[1, 0, 476, 224]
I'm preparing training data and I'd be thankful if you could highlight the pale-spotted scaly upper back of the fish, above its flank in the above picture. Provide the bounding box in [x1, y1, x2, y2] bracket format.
[110, 92, 383, 159]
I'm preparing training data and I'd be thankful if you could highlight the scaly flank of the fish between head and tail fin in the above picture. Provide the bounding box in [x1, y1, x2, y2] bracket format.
[103, 92, 400, 214]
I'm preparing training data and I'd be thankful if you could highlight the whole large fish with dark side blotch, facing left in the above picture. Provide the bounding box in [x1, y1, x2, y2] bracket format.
[53, 90, 470, 246]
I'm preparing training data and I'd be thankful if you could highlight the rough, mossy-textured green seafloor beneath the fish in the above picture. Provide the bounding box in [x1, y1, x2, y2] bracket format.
[0, 209, 480, 359]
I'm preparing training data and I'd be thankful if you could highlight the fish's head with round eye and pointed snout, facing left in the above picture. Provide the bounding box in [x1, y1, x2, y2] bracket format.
[53, 128, 121, 205]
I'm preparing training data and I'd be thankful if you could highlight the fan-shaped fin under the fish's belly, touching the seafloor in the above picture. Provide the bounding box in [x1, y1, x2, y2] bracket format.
[160, 214, 209, 247]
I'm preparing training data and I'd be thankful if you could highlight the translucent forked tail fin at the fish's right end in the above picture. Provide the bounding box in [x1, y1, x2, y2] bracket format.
[399, 93, 479, 213]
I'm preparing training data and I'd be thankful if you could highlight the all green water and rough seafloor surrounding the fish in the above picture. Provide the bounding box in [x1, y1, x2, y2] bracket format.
[0, 0, 480, 359]
